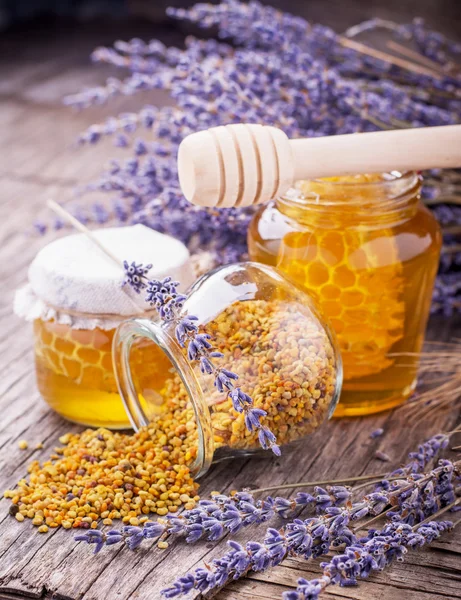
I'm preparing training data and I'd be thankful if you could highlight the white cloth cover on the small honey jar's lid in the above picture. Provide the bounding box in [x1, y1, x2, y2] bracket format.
[15, 225, 194, 327]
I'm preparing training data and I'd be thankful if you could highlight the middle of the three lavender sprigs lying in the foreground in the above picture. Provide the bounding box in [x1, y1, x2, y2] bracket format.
[163, 460, 461, 598]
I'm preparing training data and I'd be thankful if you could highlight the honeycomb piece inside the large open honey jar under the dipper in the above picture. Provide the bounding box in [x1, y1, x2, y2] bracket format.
[278, 228, 404, 380]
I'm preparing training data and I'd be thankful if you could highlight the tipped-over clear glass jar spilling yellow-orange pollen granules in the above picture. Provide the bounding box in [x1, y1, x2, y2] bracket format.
[114, 263, 342, 475]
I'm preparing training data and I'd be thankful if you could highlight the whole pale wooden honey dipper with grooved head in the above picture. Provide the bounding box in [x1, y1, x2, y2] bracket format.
[178, 124, 461, 208]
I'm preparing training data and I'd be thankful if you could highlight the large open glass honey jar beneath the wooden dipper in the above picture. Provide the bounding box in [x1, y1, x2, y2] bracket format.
[248, 172, 442, 416]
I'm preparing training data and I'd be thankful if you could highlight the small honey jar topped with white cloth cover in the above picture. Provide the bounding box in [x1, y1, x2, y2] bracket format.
[15, 225, 193, 429]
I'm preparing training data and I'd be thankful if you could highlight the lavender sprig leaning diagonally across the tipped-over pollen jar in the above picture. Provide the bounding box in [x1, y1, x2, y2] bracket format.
[123, 261, 281, 456]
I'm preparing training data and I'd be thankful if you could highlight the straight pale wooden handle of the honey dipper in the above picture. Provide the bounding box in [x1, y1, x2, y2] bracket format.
[290, 125, 461, 180]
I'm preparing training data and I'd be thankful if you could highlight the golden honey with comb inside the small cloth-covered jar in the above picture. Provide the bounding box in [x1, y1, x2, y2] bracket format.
[34, 319, 171, 429]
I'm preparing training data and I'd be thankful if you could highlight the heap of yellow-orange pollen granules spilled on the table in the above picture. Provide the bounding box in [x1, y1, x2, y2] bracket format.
[4, 418, 198, 532]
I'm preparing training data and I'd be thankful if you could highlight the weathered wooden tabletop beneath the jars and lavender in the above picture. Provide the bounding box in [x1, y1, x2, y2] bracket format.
[0, 12, 461, 600]
